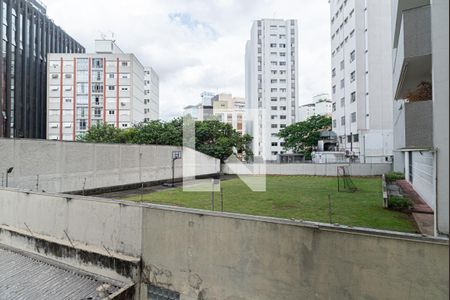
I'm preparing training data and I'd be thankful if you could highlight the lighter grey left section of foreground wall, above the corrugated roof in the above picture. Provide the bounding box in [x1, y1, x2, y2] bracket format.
[0, 189, 142, 257]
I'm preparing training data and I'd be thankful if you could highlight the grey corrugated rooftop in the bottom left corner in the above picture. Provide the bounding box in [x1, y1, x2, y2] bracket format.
[0, 244, 126, 300]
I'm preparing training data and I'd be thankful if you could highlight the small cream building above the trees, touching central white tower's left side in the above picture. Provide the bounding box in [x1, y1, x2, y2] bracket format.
[212, 94, 245, 135]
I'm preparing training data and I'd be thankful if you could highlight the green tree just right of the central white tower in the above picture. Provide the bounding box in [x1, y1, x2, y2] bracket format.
[278, 116, 332, 159]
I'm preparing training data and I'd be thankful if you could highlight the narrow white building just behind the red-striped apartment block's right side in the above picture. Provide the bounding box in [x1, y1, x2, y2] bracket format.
[144, 67, 159, 122]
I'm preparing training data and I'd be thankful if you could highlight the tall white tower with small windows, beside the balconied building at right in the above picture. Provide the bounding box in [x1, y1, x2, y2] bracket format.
[330, 0, 393, 163]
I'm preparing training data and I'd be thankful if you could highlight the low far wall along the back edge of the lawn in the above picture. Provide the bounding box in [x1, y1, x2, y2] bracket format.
[222, 163, 392, 176]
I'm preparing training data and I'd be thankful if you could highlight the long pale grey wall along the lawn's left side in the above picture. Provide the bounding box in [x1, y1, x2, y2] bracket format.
[0, 139, 220, 192]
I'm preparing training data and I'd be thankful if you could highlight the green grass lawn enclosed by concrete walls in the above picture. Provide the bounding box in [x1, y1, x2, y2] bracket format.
[127, 176, 416, 232]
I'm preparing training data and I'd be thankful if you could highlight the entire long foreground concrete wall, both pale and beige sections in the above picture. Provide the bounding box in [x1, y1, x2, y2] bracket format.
[0, 189, 449, 300]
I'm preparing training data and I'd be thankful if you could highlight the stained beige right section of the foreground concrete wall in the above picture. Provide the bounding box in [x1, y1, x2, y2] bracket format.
[141, 207, 449, 300]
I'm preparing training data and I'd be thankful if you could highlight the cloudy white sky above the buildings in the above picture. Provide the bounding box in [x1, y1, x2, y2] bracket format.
[44, 0, 331, 120]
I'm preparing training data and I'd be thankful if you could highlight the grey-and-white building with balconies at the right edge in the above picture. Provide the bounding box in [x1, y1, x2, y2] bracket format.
[392, 0, 449, 235]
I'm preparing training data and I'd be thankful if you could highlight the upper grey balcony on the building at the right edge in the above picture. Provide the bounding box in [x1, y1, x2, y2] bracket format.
[394, 5, 432, 99]
